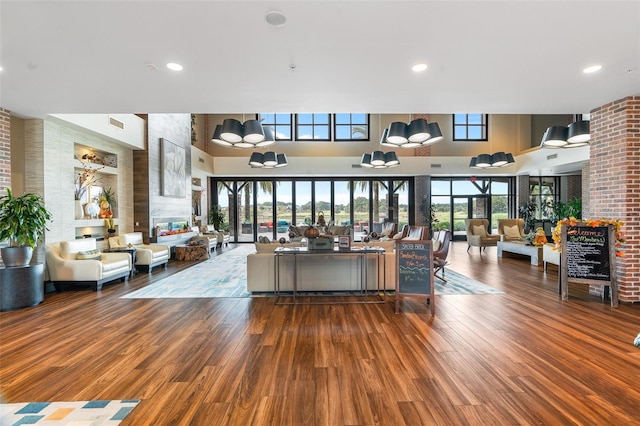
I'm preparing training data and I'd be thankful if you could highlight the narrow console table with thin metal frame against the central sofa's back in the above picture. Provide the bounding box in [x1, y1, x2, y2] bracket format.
[274, 247, 386, 305]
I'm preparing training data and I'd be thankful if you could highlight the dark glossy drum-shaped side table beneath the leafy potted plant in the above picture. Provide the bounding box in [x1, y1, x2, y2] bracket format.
[0, 263, 44, 311]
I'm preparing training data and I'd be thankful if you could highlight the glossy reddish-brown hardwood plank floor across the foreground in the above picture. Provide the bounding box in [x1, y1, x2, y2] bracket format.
[0, 242, 640, 425]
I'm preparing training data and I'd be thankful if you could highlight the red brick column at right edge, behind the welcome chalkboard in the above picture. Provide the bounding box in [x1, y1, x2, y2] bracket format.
[583, 96, 640, 302]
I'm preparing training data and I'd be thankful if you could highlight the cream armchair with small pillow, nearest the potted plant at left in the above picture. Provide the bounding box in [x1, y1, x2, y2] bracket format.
[45, 238, 132, 291]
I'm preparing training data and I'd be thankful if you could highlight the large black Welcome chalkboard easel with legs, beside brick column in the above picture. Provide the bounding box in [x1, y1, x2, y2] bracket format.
[560, 222, 618, 307]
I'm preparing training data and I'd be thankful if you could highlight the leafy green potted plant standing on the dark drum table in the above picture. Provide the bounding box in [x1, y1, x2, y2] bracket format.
[0, 188, 51, 266]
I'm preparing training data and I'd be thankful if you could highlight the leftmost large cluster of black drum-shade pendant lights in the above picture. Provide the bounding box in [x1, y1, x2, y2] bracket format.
[211, 118, 276, 148]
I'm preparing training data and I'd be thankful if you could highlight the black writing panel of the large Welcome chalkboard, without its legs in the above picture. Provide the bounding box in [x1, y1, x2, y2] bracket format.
[565, 226, 611, 281]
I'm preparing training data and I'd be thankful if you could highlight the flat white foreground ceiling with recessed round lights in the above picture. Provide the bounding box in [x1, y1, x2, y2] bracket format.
[0, 0, 640, 117]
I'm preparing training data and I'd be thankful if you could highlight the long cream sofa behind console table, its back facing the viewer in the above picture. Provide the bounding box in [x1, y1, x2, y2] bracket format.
[247, 241, 396, 292]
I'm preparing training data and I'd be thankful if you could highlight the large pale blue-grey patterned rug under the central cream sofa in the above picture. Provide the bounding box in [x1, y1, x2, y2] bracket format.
[121, 244, 502, 299]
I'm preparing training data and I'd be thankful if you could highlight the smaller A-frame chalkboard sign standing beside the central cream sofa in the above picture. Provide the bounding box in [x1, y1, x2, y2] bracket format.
[396, 240, 434, 315]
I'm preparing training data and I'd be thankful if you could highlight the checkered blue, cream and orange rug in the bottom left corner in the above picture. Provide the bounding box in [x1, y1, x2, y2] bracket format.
[0, 399, 140, 426]
